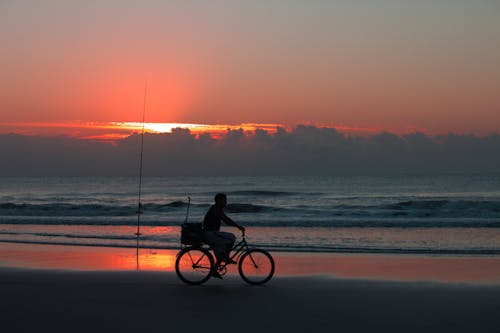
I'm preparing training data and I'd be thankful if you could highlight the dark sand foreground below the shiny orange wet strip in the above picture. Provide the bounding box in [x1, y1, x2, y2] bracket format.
[0, 268, 500, 332]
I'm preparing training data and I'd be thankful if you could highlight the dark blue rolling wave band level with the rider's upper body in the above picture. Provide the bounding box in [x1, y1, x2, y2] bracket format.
[0, 199, 500, 227]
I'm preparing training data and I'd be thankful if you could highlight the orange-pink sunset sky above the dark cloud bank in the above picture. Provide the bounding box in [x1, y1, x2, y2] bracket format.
[0, 0, 500, 135]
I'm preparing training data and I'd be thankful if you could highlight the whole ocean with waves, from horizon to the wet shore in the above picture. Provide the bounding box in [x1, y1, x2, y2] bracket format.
[0, 175, 500, 255]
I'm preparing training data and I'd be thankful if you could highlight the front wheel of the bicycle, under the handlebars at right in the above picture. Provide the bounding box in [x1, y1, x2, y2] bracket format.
[238, 249, 274, 284]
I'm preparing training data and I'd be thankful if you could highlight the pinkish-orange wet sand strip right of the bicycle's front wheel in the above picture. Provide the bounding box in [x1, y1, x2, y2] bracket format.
[276, 253, 500, 284]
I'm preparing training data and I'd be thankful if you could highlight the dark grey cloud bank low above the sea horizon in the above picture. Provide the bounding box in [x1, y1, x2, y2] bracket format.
[0, 126, 500, 176]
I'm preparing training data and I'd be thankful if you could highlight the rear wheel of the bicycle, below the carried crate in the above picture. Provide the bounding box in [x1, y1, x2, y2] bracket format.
[175, 246, 214, 284]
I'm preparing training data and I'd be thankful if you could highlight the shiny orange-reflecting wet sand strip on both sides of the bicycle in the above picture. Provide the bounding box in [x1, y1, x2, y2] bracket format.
[0, 242, 500, 286]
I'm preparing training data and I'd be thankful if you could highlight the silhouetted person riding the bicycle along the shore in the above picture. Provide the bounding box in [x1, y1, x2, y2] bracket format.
[203, 193, 245, 279]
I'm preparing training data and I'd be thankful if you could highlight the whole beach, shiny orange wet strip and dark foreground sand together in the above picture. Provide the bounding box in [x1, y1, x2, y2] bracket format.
[0, 243, 500, 332]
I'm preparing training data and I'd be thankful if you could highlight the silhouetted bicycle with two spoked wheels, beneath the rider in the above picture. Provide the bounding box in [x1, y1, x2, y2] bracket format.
[175, 231, 275, 285]
